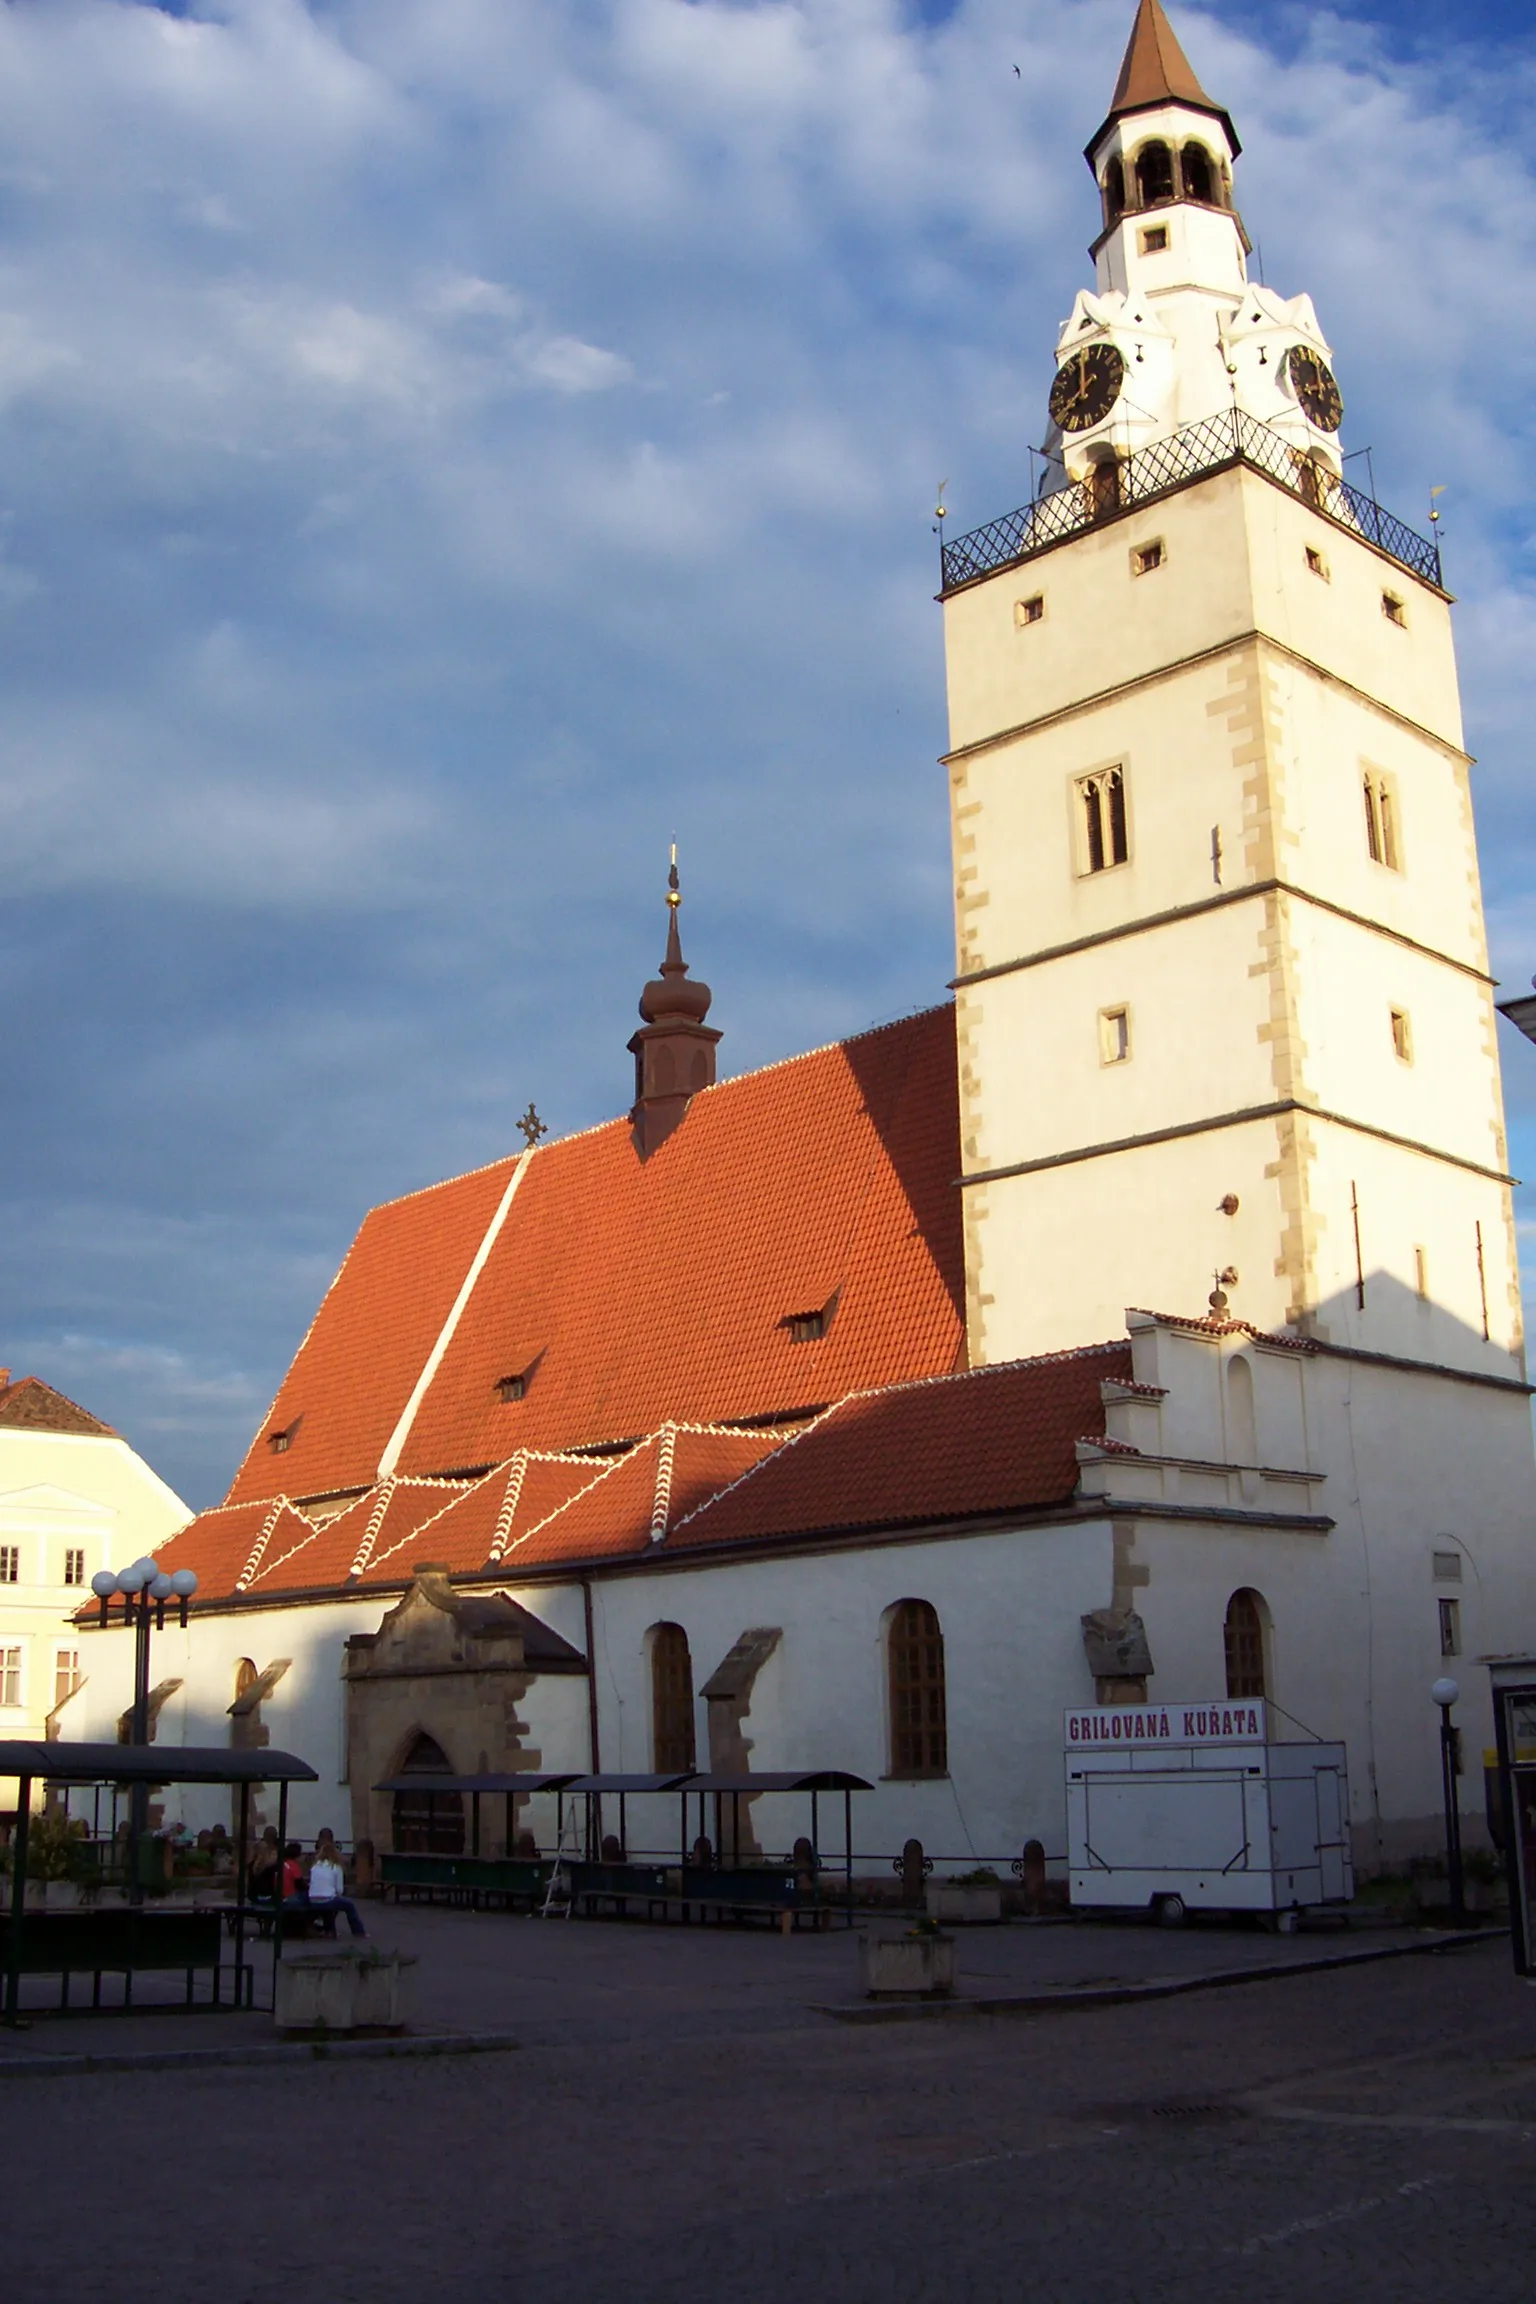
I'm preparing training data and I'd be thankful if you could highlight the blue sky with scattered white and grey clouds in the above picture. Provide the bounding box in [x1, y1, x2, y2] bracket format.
[0, 0, 1536, 1505]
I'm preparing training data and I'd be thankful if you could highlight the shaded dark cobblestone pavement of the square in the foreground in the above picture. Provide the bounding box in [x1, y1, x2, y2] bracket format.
[0, 1915, 1536, 2304]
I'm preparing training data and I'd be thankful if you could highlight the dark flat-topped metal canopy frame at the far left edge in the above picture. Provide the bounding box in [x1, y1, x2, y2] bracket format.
[0, 1740, 320, 2025]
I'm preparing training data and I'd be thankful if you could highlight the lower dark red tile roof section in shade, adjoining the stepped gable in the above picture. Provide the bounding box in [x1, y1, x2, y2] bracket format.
[668, 1343, 1131, 1553]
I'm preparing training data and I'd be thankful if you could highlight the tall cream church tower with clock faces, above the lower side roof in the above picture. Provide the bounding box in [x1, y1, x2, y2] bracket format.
[942, 0, 1524, 1375]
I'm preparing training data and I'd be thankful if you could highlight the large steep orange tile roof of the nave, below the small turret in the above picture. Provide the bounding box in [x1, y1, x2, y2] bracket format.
[230, 1007, 965, 1502]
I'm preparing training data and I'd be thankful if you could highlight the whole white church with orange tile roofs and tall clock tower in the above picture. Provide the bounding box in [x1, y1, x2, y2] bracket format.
[67, 0, 1536, 1869]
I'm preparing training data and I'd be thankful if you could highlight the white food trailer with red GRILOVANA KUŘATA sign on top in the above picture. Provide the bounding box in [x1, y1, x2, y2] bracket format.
[1064, 1700, 1354, 1926]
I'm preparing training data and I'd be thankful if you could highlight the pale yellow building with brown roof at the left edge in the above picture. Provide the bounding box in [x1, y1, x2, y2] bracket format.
[0, 1369, 187, 1818]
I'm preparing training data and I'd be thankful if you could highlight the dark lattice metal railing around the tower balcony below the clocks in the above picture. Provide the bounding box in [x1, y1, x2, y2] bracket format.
[940, 408, 1439, 592]
